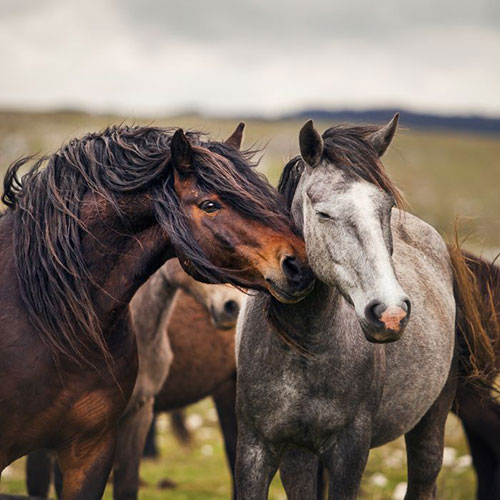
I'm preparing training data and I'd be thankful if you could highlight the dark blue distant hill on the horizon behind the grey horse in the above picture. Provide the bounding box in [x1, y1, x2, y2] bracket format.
[283, 108, 500, 134]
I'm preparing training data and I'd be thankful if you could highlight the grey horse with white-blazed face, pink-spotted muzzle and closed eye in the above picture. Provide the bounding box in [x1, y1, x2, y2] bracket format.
[236, 115, 486, 500]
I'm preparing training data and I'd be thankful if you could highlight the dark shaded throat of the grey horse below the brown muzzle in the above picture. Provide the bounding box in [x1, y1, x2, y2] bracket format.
[273, 280, 343, 353]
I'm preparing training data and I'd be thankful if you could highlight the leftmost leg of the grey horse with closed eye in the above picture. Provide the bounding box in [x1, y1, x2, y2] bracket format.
[236, 430, 280, 500]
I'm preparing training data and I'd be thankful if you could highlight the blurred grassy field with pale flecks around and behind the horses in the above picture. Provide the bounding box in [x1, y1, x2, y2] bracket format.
[0, 112, 500, 500]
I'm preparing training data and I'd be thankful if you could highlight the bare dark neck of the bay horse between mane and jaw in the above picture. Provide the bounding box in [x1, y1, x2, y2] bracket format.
[81, 195, 175, 331]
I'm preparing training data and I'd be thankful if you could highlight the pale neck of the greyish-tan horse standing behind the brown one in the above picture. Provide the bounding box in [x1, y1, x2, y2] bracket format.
[130, 268, 178, 337]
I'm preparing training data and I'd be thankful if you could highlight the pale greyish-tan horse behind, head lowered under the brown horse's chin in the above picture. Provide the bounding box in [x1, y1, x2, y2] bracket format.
[113, 259, 244, 500]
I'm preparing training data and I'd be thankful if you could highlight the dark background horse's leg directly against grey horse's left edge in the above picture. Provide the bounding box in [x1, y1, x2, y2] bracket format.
[212, 374, 238, 500]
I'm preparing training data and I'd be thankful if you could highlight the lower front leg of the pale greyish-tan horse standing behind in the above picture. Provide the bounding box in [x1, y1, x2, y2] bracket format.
[113, 398, 154, 500]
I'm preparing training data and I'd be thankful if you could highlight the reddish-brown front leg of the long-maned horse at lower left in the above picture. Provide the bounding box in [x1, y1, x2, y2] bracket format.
[57, 429, 117, 500]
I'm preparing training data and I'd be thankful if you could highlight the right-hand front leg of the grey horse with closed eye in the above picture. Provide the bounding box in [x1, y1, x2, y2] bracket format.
[320, 418, 371, 500]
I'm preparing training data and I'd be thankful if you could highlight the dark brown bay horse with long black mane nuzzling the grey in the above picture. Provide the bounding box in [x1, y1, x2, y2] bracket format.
[0, 122, 313, 500]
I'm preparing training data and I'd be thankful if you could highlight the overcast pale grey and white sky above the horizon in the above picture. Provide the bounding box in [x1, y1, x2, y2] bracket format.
[0, 0, 500, 116]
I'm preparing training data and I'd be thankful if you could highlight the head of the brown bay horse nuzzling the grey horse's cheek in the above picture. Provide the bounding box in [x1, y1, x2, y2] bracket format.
[162, 124, 313, 302]
